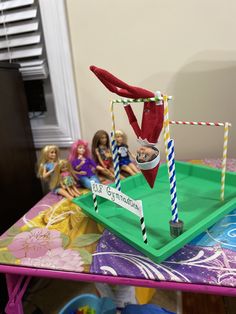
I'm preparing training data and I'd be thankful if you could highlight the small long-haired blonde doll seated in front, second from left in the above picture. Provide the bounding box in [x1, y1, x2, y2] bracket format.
[50, 159, 81, 201]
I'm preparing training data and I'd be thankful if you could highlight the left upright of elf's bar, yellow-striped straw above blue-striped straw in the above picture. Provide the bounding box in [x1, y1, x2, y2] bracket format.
[110, 101, 121, 191]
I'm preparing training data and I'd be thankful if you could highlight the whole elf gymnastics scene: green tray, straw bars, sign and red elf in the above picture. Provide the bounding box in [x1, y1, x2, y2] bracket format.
[73, 66, 236, 262]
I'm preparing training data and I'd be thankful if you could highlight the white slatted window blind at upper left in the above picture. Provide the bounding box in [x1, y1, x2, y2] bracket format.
[0, 0, 48, 80]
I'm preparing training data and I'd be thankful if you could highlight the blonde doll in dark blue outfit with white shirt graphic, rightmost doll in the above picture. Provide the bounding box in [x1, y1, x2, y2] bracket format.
[115, 130, 139, 176]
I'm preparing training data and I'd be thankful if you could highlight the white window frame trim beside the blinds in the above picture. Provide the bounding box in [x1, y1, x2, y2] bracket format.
[31, 0, 81, 148]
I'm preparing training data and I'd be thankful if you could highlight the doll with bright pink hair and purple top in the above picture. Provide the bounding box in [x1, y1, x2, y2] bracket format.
[69, 140, 100, 190]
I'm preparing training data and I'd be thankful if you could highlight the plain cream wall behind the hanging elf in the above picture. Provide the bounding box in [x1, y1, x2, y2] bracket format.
[66, 0, 236, 159]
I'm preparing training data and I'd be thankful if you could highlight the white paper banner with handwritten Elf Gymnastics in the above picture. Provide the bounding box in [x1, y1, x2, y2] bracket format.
[91, 181, 142, 217]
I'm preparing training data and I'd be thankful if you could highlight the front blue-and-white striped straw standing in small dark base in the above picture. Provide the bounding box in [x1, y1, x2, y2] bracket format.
[168, 139, 179, 222]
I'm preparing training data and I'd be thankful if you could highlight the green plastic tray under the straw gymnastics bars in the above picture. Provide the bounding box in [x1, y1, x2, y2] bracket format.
[74, 162, 236, 263]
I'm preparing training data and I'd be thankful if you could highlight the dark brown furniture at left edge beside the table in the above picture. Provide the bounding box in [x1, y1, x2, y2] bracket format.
[0, 63, 42, 234]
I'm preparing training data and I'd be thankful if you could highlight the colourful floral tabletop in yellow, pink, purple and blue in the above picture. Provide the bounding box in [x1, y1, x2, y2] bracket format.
[0, 159, 236, 287]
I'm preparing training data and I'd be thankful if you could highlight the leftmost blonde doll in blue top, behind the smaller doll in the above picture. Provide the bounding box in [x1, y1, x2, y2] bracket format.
[38, 145, 59, 181]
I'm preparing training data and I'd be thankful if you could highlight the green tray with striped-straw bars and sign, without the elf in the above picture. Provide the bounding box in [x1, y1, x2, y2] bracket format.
[75, 95, 232, 262]
